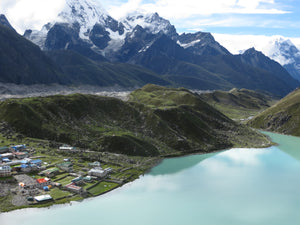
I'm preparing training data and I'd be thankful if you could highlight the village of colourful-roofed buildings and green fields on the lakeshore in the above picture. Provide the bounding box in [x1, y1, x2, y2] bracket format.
[0, 140, 158, 212]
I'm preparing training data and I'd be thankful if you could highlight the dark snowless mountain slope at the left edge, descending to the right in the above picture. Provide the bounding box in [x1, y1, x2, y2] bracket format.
[0, 24, 67, 84]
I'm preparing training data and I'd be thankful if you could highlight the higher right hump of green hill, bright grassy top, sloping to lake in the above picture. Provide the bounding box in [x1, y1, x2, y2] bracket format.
[129, 85, 264, 149]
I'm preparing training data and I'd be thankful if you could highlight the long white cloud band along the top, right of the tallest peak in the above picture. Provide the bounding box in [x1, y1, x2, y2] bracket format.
[109, 0, 288, 19]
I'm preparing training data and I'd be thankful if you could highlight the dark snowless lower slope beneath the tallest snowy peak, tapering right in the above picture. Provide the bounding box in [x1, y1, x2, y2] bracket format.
[47, 50, 170, 88]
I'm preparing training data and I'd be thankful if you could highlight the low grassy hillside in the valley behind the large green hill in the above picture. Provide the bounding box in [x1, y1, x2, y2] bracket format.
[200, 88, 277, 120]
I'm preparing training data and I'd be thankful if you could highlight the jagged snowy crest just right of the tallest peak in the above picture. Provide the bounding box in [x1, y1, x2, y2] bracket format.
[121, 10, 176, 36]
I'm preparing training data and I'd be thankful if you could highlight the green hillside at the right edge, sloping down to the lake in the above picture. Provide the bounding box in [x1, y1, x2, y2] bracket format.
[249, 88, 300, 136]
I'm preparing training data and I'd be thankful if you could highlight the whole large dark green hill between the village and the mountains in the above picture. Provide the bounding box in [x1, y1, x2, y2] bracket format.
[0, 85, 267, 156]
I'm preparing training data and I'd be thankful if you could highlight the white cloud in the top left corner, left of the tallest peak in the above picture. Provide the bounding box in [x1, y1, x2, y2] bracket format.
[0, 0, 64, 33]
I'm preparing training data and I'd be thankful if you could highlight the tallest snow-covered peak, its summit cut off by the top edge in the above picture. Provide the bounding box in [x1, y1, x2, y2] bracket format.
[24, 0, 125, 59]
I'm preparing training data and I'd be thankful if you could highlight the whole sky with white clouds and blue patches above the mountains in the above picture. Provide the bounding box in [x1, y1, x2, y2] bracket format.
[0, 0, 300, 37]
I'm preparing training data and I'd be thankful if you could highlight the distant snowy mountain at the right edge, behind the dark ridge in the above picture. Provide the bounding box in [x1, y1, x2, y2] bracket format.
[262, 37, 300, 80]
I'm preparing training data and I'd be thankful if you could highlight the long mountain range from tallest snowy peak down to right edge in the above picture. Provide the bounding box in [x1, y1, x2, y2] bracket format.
[1, 0, 300, 96]
